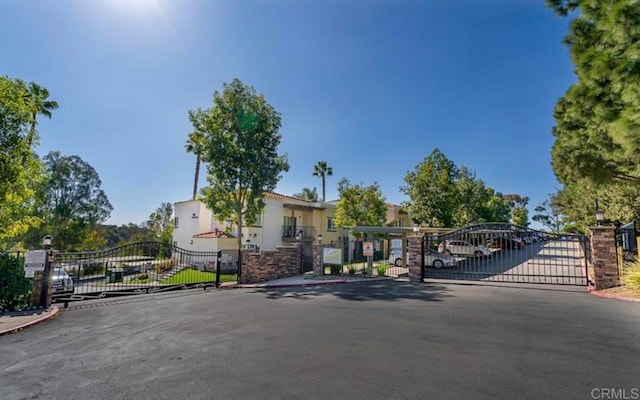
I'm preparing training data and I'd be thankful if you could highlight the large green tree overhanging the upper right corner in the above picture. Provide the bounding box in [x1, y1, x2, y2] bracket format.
[547, 0, 640, 185]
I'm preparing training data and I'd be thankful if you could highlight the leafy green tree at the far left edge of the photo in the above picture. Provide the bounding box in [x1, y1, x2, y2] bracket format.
[0, 76, 43, 242]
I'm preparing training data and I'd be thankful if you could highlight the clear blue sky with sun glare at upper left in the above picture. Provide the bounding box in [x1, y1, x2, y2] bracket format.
[0, 0, 575, 224]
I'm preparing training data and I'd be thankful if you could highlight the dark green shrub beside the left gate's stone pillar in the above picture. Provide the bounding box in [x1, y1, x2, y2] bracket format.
[0, 253, 33, 310]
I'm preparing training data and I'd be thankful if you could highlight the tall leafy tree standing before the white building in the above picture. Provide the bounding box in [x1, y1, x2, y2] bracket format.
[196, 79, 289, 268]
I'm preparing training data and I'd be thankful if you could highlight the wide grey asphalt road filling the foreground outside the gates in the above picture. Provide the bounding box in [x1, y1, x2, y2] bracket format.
[0, 281, 640, 400]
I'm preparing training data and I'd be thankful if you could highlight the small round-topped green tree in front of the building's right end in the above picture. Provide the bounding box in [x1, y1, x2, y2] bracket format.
[335, 178, 387, 231]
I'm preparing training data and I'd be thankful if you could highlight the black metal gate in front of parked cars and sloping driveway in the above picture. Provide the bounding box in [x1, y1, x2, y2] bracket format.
[423, 223, 590, 286]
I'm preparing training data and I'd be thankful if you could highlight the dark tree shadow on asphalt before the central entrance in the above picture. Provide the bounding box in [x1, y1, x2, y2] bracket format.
[250, 279, 452, 301]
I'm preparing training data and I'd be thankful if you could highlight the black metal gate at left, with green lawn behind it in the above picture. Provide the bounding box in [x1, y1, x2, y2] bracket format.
[52, 242, 238, 302]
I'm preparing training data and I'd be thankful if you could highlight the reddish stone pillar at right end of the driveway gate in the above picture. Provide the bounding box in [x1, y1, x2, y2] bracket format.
[591, 226, 620, 290]
